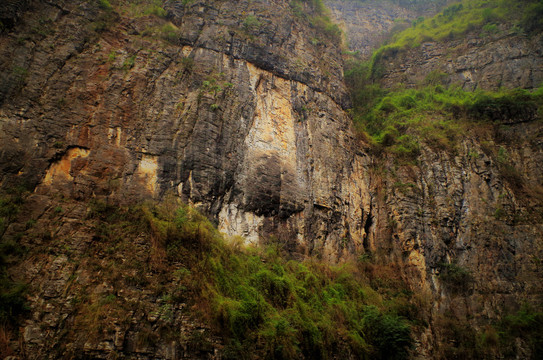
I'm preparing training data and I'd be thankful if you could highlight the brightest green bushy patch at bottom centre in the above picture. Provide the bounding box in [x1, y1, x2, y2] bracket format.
[208, 243, 412, 359]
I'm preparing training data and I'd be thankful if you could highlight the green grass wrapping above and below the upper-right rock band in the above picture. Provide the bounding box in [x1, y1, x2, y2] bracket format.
[345, 0, 543, 161]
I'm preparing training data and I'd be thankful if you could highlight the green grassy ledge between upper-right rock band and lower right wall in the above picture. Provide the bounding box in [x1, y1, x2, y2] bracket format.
[345, 55, 543, 162]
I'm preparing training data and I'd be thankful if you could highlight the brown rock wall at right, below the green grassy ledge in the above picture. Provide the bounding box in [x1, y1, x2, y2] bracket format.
[372, 122, 543, 358]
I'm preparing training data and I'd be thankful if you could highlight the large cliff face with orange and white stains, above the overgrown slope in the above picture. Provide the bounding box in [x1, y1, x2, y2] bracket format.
[1, 2, 369, 258]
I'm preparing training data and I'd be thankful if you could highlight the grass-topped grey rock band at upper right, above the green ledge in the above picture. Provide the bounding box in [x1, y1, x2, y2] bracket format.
[374, 1, 543, 90]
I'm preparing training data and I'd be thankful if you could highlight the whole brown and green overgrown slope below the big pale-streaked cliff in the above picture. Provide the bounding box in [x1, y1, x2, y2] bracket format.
[2, 195, 416, 359]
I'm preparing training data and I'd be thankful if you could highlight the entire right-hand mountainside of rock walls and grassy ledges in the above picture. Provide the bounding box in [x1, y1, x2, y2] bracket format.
[348, 2, 543, 359]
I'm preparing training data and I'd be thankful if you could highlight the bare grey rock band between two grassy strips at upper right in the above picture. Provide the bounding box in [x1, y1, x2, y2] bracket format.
[379, 28, 543, 91]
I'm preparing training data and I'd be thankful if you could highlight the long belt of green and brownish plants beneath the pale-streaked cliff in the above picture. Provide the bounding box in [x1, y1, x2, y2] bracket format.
[87, 199, 414, 359]
